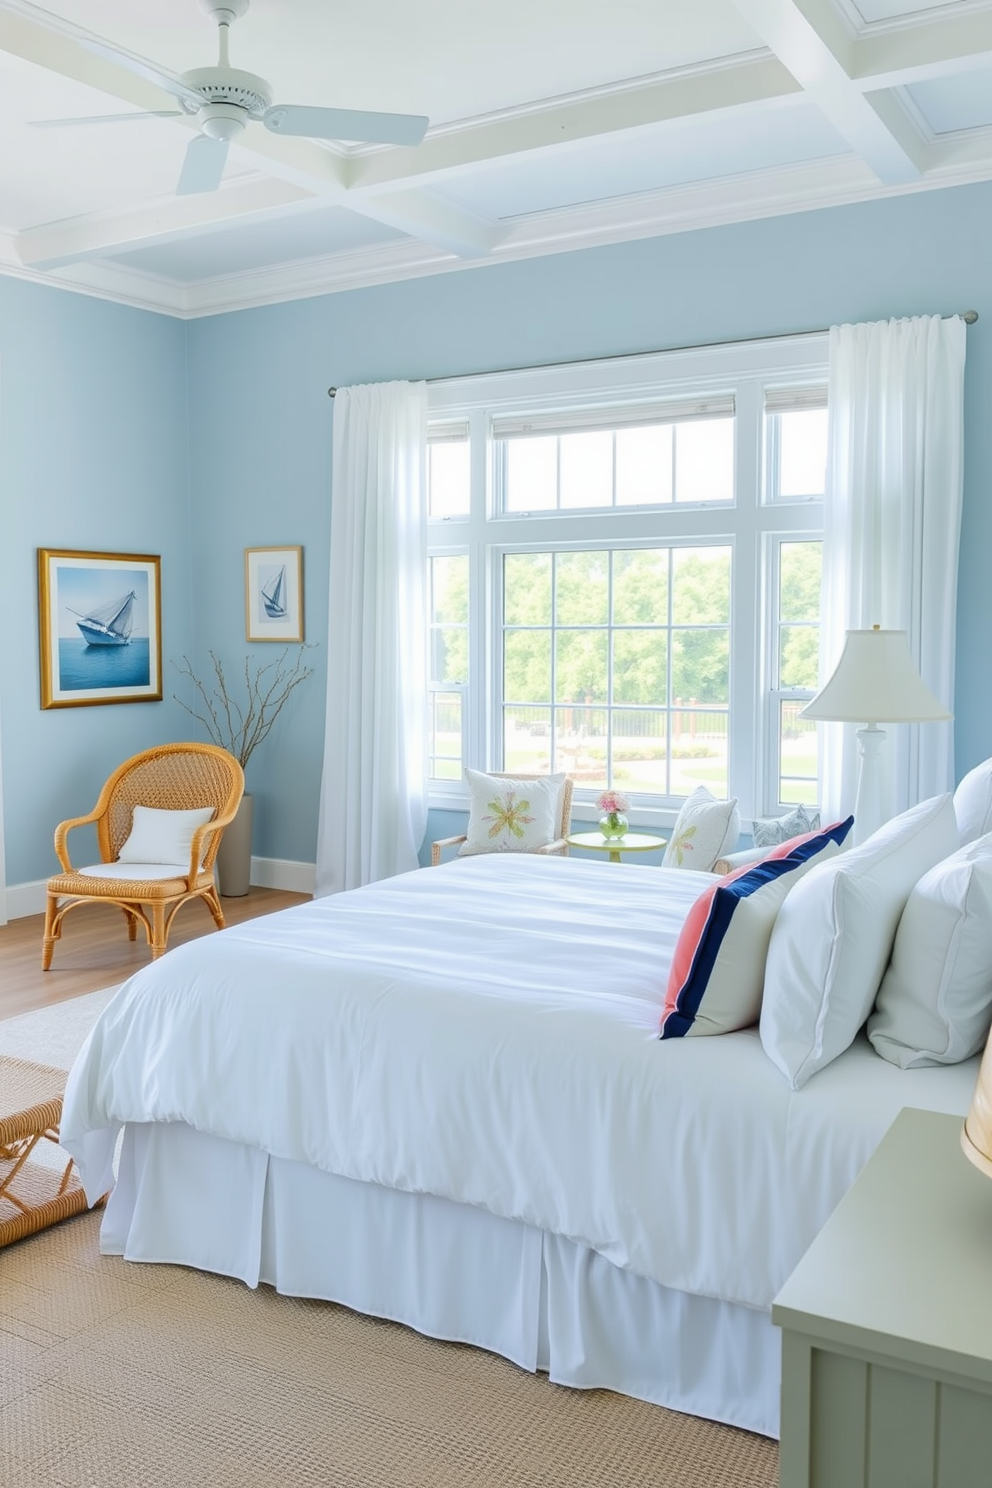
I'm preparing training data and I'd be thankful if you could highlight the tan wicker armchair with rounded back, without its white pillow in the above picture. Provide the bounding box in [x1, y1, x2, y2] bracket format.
[42, 744, 244, 972]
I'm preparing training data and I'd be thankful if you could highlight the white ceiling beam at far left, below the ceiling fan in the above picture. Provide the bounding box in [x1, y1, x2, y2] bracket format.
[15, 177, 314, 268]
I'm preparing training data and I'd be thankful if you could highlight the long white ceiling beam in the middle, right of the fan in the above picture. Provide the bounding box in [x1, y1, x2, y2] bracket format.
[345, 52, 800, 195]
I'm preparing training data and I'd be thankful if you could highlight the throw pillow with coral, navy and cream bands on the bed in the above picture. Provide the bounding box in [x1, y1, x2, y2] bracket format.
[662, 817, 854, 1039]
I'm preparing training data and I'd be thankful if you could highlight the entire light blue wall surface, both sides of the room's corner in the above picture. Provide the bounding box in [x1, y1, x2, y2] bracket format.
[0, 185, 992, 884]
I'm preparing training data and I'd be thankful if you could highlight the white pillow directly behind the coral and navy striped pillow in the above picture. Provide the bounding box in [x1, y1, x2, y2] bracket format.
[760, 795, 958, 1091]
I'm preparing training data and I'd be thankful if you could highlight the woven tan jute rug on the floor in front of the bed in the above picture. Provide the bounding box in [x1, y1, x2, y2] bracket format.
[0, 1214, 778, 1488]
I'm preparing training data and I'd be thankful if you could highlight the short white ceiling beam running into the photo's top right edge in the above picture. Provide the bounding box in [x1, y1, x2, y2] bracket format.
[851, 10, 992, 92]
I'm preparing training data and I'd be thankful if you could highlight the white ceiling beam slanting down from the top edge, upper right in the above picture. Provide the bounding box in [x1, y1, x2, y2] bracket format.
[733, 0, 927, 186]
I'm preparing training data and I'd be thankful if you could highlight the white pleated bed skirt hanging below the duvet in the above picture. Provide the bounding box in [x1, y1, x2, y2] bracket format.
[101, 1122, 781, 1436]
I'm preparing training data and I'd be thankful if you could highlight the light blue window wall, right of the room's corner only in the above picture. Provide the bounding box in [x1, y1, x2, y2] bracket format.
[189, 185, 992, 860]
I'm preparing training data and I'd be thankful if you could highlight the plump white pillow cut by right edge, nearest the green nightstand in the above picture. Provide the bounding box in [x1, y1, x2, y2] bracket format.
[869, 833, 992, 1070]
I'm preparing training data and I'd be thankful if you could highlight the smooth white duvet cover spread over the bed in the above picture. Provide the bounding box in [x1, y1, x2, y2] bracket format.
[61, 856, 977, 1308]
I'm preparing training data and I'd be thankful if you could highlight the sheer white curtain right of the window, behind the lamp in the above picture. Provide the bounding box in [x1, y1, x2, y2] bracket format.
[819, 315, 967, 820]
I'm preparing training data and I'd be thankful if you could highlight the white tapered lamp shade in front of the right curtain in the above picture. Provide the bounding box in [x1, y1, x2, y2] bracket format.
[800, 625, 953, 723]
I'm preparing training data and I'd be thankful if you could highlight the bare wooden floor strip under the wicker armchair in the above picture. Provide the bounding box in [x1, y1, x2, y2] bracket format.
[0, 888, 309, 1018]
